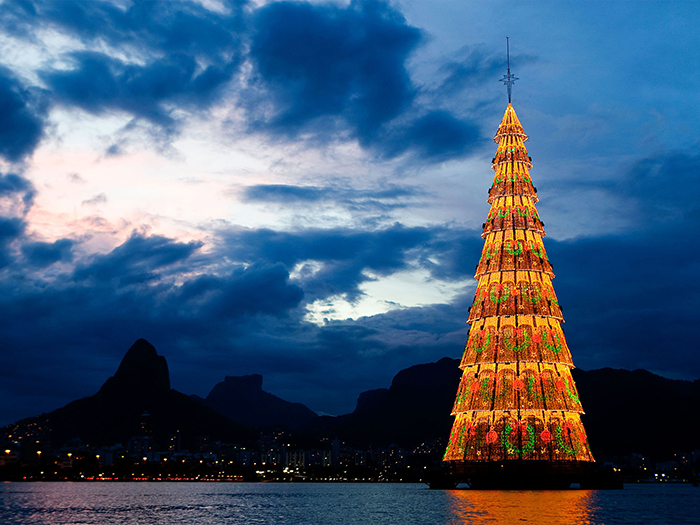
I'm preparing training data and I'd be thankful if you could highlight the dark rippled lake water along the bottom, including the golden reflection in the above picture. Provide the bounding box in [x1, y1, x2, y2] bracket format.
[0, 482, 700, 525]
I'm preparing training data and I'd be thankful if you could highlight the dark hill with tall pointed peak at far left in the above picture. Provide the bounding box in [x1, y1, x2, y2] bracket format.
[2, 339, 256, 449]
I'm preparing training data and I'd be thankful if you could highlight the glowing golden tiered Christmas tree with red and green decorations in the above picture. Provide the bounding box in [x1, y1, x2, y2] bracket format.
[444, 102, 593, 472]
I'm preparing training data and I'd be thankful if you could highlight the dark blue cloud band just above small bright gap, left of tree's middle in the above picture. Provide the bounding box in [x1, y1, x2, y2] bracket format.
[222, 224, 483, 292]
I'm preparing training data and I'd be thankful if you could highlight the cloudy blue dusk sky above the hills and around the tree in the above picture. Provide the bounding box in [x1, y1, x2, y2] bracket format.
[0, 0, 700, 424]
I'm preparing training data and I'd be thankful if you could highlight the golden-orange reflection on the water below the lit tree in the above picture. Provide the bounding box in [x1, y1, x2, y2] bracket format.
[449, 490, 596, 525]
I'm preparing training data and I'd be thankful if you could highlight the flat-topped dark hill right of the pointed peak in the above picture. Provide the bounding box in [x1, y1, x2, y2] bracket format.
[192, 374, 319, 430]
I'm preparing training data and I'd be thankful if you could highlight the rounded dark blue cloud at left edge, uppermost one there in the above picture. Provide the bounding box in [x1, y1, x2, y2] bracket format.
[0, 67, 46, 162]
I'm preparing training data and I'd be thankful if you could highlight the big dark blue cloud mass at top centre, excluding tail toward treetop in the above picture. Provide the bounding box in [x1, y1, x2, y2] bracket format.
[251, 1, 421, 135]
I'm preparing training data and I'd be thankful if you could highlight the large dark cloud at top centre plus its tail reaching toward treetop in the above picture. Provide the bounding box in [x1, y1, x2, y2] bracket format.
[247, 0, 479, 161]
